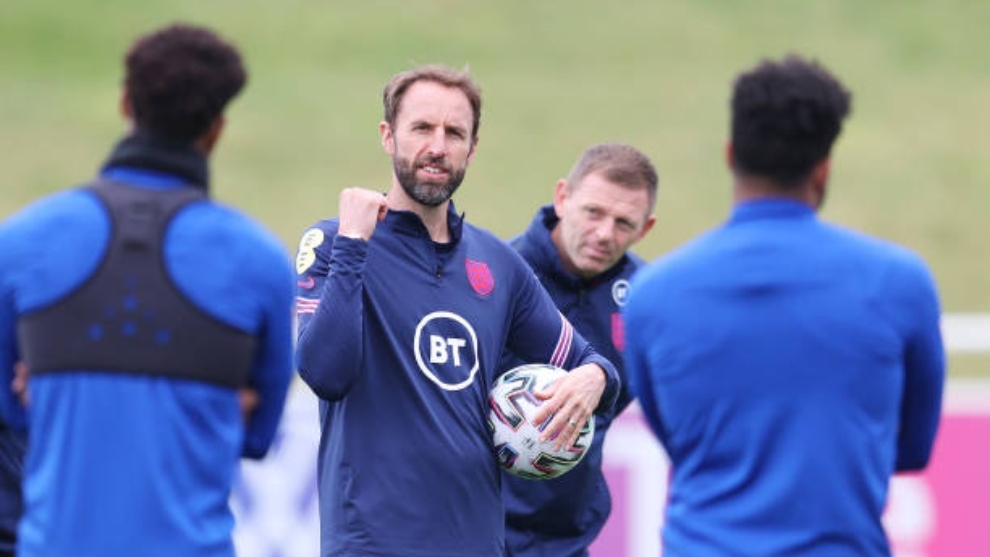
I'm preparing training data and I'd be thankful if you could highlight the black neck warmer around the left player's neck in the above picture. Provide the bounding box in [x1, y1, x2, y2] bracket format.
[101, 130, 210, 190]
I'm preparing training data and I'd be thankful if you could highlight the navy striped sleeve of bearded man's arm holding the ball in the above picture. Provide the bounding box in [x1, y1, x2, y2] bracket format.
[508, 268, 619, 413]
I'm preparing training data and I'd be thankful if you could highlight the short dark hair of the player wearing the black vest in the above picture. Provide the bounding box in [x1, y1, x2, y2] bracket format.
[124, 23, 247, 141]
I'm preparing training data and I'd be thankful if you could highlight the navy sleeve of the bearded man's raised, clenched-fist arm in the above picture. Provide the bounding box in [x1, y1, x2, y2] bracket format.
[296, 228, 368, 401]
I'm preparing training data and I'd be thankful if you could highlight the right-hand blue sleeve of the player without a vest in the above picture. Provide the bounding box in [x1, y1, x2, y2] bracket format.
[896, 258, 945, 472]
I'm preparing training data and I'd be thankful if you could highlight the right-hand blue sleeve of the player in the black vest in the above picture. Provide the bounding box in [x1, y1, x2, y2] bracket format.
[242, 243, 293, 458]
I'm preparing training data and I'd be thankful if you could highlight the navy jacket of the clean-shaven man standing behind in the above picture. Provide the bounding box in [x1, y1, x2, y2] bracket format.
[502, 205, 642, 557]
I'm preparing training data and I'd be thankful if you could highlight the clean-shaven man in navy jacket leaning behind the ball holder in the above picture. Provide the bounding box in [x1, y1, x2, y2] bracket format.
[502, 143, 657, 557]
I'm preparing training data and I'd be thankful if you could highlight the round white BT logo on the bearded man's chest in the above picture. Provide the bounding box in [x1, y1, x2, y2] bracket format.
[413, 311, 479, 391]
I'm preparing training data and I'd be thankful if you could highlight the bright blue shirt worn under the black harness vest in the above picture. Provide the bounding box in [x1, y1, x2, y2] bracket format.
[0, 135, 293, 557]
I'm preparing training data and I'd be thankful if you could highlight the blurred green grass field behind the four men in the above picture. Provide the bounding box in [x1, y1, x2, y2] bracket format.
[0, 0, 990, 375]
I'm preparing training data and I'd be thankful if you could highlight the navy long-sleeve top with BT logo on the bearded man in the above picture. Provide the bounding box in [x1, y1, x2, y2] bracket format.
[297, 206, 618, 557]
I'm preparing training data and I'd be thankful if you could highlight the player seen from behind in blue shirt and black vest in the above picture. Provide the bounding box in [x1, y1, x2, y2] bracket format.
[0, 24, 294, 557]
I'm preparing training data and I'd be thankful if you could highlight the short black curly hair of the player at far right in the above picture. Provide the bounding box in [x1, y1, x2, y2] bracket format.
[732, 54, 852, 189]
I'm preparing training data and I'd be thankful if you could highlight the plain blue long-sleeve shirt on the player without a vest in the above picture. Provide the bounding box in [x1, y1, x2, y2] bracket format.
[625, 199, 945, 557]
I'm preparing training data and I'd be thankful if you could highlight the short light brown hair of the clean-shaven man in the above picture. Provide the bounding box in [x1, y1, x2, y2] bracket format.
[567, 143, 659, 214]
